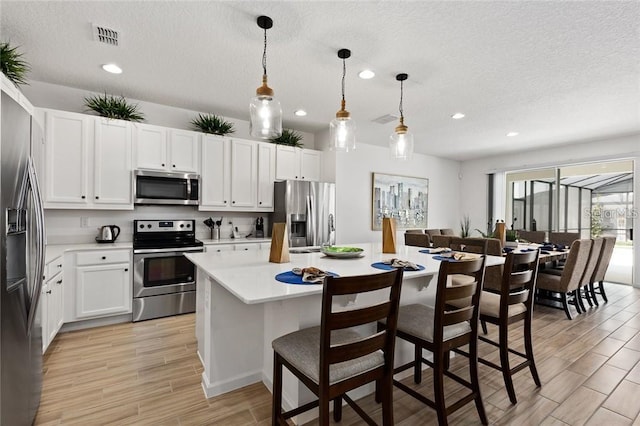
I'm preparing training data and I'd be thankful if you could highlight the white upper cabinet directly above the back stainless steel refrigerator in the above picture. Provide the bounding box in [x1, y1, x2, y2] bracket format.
[276, 145, 322, 181]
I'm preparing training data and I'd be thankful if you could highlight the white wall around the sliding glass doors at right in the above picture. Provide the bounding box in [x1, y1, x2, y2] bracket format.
[460, 135, 640, 287]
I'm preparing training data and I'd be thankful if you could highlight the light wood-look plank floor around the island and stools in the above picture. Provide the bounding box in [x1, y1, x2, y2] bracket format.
[35, 284, 640, 426]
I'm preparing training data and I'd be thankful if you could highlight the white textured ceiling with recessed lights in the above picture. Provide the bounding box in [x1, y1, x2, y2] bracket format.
[0, 0, 640, 159]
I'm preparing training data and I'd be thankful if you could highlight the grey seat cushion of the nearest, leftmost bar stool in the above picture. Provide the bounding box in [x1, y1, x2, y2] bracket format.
[272, 326, 384, 384]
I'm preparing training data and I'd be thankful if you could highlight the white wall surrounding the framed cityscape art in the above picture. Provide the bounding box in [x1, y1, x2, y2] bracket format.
[324, 143, 461, 244]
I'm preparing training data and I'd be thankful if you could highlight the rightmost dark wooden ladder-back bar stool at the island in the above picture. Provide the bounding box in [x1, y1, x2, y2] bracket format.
[452, 250, 542, 404]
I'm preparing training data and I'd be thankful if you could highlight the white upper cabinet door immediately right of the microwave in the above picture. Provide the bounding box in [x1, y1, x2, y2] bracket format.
[200, 135, 231, 210]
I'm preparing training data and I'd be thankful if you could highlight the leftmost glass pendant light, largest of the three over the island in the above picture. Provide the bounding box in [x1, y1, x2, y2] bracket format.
[249, 16, 282, 139]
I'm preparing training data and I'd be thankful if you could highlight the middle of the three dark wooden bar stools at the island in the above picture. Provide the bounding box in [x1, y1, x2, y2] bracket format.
[380, 256, 488, 425]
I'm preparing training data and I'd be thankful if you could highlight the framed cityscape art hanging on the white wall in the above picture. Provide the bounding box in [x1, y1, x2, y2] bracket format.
[371, 172, 429, 230]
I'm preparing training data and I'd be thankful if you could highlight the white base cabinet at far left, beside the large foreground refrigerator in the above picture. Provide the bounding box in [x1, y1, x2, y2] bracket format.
[40, 256, 64, 353]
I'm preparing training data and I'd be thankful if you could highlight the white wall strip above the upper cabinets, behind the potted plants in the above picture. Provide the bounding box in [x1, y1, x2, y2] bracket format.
[20, 80, 315, 149]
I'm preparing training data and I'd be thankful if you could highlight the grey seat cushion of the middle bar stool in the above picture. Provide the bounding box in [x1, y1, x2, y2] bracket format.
[398, 304, 471, 342]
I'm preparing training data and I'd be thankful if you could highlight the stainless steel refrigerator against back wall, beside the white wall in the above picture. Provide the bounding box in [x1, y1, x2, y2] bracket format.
[271, 180, 336, 247]
